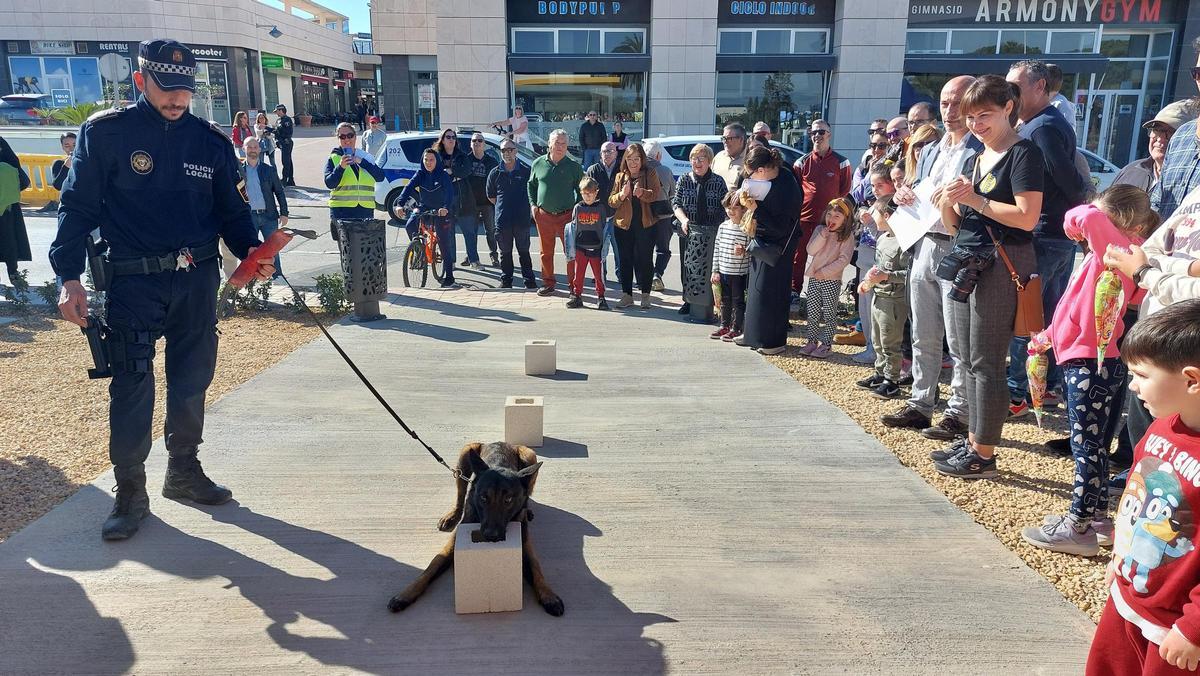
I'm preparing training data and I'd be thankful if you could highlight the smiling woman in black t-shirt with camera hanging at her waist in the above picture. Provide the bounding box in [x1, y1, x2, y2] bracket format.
[930, 76, 1043, 479]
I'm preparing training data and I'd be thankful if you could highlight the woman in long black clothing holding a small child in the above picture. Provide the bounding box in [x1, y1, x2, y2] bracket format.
[737, 145, 804, 354]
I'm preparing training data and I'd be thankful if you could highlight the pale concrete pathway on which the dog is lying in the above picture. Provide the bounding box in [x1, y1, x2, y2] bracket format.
[0, 277, 1092, 675]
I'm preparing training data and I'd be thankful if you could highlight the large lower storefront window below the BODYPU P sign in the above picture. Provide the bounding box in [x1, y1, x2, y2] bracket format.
[512, 73, 646, 148]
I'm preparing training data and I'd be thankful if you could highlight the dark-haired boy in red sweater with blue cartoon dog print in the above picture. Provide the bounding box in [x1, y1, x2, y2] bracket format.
[1087, 299, 1200, 676]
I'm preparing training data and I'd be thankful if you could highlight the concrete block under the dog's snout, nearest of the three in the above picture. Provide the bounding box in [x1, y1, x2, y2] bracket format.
[454, 521, 523, 614]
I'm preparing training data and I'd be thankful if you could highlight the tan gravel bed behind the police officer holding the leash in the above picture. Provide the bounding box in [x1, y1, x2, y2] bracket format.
[0, 305, 319, 542]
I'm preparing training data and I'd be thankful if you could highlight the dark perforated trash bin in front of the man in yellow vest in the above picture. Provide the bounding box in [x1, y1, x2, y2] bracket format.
[334, 219, 388, 322]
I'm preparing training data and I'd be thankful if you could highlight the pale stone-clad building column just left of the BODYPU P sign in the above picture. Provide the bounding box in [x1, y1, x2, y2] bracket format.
[437, 0, 509, 128]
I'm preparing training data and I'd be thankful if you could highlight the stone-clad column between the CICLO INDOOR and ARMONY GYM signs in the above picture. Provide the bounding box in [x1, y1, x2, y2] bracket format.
[829, 0, 908, 162]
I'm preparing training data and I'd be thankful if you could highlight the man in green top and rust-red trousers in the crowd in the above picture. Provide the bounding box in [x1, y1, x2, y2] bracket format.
[529, 130, 583, 295]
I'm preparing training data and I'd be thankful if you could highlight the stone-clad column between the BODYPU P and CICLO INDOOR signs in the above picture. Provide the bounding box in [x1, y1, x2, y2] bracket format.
[646, 0, 718, 137]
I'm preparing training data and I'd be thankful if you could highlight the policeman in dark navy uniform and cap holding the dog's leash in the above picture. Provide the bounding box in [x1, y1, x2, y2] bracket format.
[50, 40, 275, 540]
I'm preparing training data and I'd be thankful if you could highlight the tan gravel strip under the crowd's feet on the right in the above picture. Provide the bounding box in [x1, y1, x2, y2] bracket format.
[768, 322, 1110, 621]
